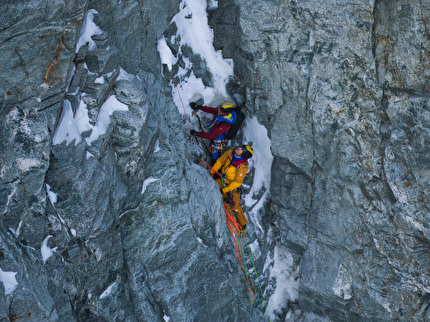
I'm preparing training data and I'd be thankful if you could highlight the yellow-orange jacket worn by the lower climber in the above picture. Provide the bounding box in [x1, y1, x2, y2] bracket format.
[210, 149, 248, 193]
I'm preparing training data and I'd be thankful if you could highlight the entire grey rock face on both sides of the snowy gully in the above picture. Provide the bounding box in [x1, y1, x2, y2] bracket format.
[0, 0, 430, 321]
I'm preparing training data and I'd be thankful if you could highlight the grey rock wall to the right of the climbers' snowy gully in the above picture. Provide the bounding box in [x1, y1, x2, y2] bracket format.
[233, 1, 430, 321]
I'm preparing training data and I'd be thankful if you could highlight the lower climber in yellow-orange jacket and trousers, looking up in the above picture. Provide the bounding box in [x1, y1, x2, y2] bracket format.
[210, 145, 254, 231]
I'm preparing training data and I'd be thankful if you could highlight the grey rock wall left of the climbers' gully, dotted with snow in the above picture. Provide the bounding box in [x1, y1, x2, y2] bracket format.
[0, 1, 262, 321]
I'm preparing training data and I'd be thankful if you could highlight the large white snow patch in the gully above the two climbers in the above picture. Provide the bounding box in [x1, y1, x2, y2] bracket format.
[157, 0, 233, 117]
